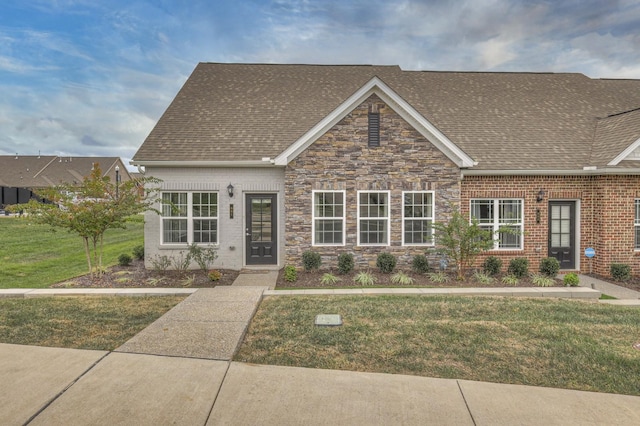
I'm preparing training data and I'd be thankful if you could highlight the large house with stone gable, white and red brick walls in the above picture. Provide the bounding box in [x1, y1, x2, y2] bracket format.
[132, 63, 640, 275]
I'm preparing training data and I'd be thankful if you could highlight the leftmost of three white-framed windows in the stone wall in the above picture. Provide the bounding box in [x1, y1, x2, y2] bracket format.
[312, 191, 345, 245]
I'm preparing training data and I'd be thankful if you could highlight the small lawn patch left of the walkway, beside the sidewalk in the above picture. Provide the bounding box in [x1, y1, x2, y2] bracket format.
[0, 296, 184, 350]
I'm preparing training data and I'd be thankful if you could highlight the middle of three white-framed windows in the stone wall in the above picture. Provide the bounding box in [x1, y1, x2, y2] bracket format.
[358, 191, 389, 246]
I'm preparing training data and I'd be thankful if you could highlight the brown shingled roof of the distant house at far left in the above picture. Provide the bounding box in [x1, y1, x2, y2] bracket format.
[0, 155, 131, 207]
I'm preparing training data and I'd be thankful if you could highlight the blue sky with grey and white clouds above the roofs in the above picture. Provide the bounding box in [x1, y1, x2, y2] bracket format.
[0, 0, 640, 170]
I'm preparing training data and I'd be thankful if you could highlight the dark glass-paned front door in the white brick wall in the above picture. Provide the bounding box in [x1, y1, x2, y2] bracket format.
[245, 194, 278, 265]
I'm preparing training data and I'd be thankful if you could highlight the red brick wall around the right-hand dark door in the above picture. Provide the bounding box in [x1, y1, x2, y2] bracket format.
[461, 176, 640, 275]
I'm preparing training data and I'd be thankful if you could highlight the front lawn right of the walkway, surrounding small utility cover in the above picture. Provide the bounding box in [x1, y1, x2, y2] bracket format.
[235, 296, 640, 395]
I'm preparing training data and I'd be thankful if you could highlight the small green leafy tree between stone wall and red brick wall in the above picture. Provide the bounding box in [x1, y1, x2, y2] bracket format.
[433, 209, 493, 281]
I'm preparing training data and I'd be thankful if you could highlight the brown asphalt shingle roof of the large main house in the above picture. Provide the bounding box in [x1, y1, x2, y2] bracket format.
[134, 63, 640, 170]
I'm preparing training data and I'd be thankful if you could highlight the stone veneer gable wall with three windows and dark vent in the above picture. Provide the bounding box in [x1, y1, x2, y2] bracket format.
[285, 95, 460, 266]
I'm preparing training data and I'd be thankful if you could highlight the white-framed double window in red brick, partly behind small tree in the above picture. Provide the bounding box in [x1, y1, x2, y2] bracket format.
[471, 199, 524, 250]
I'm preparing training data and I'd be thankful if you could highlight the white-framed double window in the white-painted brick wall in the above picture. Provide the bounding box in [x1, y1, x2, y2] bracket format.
[161, 192, 218, 244]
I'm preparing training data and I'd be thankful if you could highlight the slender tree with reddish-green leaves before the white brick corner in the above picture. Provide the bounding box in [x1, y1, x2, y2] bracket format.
[11, 163, 159, 278]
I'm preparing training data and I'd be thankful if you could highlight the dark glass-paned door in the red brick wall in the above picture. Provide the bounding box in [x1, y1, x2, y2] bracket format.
[549, 201, 576, 269]
